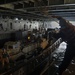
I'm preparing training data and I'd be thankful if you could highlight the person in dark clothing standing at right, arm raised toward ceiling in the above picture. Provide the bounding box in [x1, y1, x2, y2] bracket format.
[52, 17, 75, 75]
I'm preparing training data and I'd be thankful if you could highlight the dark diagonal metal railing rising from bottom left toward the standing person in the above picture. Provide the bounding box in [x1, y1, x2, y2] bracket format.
[1, 38, 61, 75]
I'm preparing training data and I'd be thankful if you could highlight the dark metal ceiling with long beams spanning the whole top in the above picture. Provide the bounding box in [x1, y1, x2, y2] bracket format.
[0, 0, 75, 19]
